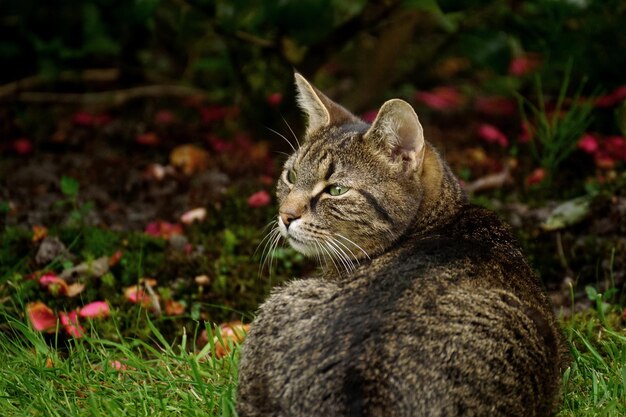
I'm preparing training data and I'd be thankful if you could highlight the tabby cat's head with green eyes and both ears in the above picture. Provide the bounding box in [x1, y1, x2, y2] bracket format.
[277, 74, 436, 268]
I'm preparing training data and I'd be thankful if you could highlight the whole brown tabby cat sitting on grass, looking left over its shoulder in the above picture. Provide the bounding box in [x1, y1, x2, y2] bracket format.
[237, 74, 567, 417]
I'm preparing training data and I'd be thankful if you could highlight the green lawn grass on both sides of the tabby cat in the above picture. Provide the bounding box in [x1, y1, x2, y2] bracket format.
[0, 309, 626, 417]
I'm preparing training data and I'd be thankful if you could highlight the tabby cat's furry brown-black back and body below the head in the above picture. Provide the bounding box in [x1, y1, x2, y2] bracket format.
[240, 207, 557, 416]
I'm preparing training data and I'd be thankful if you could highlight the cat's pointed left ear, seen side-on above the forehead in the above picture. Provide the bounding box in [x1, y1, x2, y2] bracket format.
[294, 72, 359, 135]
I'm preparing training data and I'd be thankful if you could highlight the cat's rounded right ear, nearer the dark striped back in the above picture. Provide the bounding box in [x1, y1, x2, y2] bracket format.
[365, 99, 425, 169]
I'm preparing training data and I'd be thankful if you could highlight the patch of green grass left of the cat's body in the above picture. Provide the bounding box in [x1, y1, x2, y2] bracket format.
[0, 319, 237, 417]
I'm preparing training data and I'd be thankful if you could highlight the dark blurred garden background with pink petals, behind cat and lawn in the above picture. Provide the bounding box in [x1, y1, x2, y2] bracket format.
[0, 0, 626, 333]
